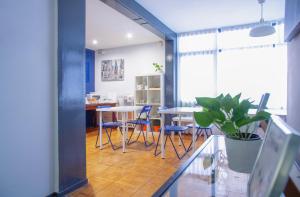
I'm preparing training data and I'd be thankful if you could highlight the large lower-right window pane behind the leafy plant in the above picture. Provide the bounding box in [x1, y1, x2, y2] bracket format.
[217, 45, 287, 109]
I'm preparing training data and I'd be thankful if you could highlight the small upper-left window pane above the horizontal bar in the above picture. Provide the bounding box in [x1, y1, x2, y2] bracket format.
[178, 33, 215, 53]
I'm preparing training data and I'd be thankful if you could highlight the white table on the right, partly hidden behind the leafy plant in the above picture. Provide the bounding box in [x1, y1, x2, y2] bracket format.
[158, 107, 203, 159]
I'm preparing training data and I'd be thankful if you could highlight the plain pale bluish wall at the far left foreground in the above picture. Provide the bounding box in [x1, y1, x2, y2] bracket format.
[0, 0, 56, 197]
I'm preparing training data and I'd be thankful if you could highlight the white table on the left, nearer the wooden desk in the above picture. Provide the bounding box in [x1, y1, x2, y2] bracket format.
[96, 106, 143, 153]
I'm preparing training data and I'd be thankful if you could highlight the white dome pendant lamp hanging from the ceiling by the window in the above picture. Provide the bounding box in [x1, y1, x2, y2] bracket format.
[249, 0, 275, 37]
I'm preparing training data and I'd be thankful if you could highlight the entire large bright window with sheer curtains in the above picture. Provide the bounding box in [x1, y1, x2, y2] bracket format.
[178, 22, 287, 109]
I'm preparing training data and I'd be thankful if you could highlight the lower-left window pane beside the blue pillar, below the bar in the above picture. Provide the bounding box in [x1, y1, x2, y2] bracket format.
[179, 54, 215, 102]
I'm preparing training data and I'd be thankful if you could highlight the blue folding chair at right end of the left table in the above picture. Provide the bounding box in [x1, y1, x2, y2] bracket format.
[127, 105, 155, 147]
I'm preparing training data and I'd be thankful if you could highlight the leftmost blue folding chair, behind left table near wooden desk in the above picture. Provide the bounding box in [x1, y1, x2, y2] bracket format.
[95, 105, 123, 150]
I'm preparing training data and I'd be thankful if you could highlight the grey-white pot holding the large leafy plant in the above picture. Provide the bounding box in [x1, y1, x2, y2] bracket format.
[225, 134, 262, 173]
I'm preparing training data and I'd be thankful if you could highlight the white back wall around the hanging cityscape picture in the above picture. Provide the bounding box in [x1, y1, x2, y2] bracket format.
[95, 42, 165, 95]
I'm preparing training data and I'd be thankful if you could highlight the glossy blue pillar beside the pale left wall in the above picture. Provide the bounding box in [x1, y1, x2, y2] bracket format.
[58, 0, 87, 195]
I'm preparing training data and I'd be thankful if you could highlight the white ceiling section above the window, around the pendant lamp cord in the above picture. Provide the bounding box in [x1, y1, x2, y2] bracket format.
[136, 0, 285, 32]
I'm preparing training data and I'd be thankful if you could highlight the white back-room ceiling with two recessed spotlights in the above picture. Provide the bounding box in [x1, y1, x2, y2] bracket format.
[86, 0, 161, 50]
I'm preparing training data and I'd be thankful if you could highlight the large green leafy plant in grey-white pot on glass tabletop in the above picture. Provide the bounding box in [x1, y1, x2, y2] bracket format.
[194, 94, 270, 173]
